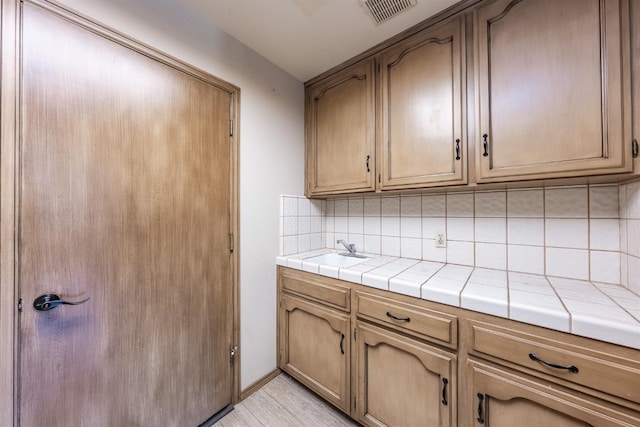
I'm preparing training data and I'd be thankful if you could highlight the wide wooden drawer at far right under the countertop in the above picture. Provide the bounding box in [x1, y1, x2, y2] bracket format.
[470, 321, 640, 402]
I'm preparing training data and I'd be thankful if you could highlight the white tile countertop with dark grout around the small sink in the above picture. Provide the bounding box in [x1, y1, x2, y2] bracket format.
[276, 249, 640, 350]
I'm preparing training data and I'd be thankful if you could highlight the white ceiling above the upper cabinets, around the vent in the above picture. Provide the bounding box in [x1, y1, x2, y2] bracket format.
[178, 0, 458, 82]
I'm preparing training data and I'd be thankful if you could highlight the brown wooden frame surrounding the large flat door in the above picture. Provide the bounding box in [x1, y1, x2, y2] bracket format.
[0, 0, 241, 427]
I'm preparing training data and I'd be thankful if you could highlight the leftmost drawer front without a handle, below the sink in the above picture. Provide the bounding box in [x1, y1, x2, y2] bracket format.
[280, 269, 351, 311]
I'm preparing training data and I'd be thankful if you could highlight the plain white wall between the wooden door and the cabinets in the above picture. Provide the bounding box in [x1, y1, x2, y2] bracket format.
[55, 0, 304, 389]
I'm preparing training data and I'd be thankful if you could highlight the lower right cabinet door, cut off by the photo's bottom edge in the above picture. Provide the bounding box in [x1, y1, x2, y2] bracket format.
[465, 361, 640, 427]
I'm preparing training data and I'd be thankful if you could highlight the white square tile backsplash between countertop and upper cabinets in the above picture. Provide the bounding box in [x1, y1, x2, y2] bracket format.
[280, 182, 640, 291]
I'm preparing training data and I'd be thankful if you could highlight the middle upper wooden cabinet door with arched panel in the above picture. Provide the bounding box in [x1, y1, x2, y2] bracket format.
[379, 17, 466, 189]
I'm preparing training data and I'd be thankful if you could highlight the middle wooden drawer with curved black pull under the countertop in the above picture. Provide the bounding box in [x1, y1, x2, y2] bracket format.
[356, 292, 458, 348]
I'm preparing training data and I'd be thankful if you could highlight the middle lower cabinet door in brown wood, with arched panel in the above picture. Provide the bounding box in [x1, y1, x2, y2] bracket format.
[355, 322, 456, 427]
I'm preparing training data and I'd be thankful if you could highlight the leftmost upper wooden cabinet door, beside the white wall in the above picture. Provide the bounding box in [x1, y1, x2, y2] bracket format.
[306, 60, 375, 195]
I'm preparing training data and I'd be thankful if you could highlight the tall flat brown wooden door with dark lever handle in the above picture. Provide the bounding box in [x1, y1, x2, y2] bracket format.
[18, 2, 233, 427]
